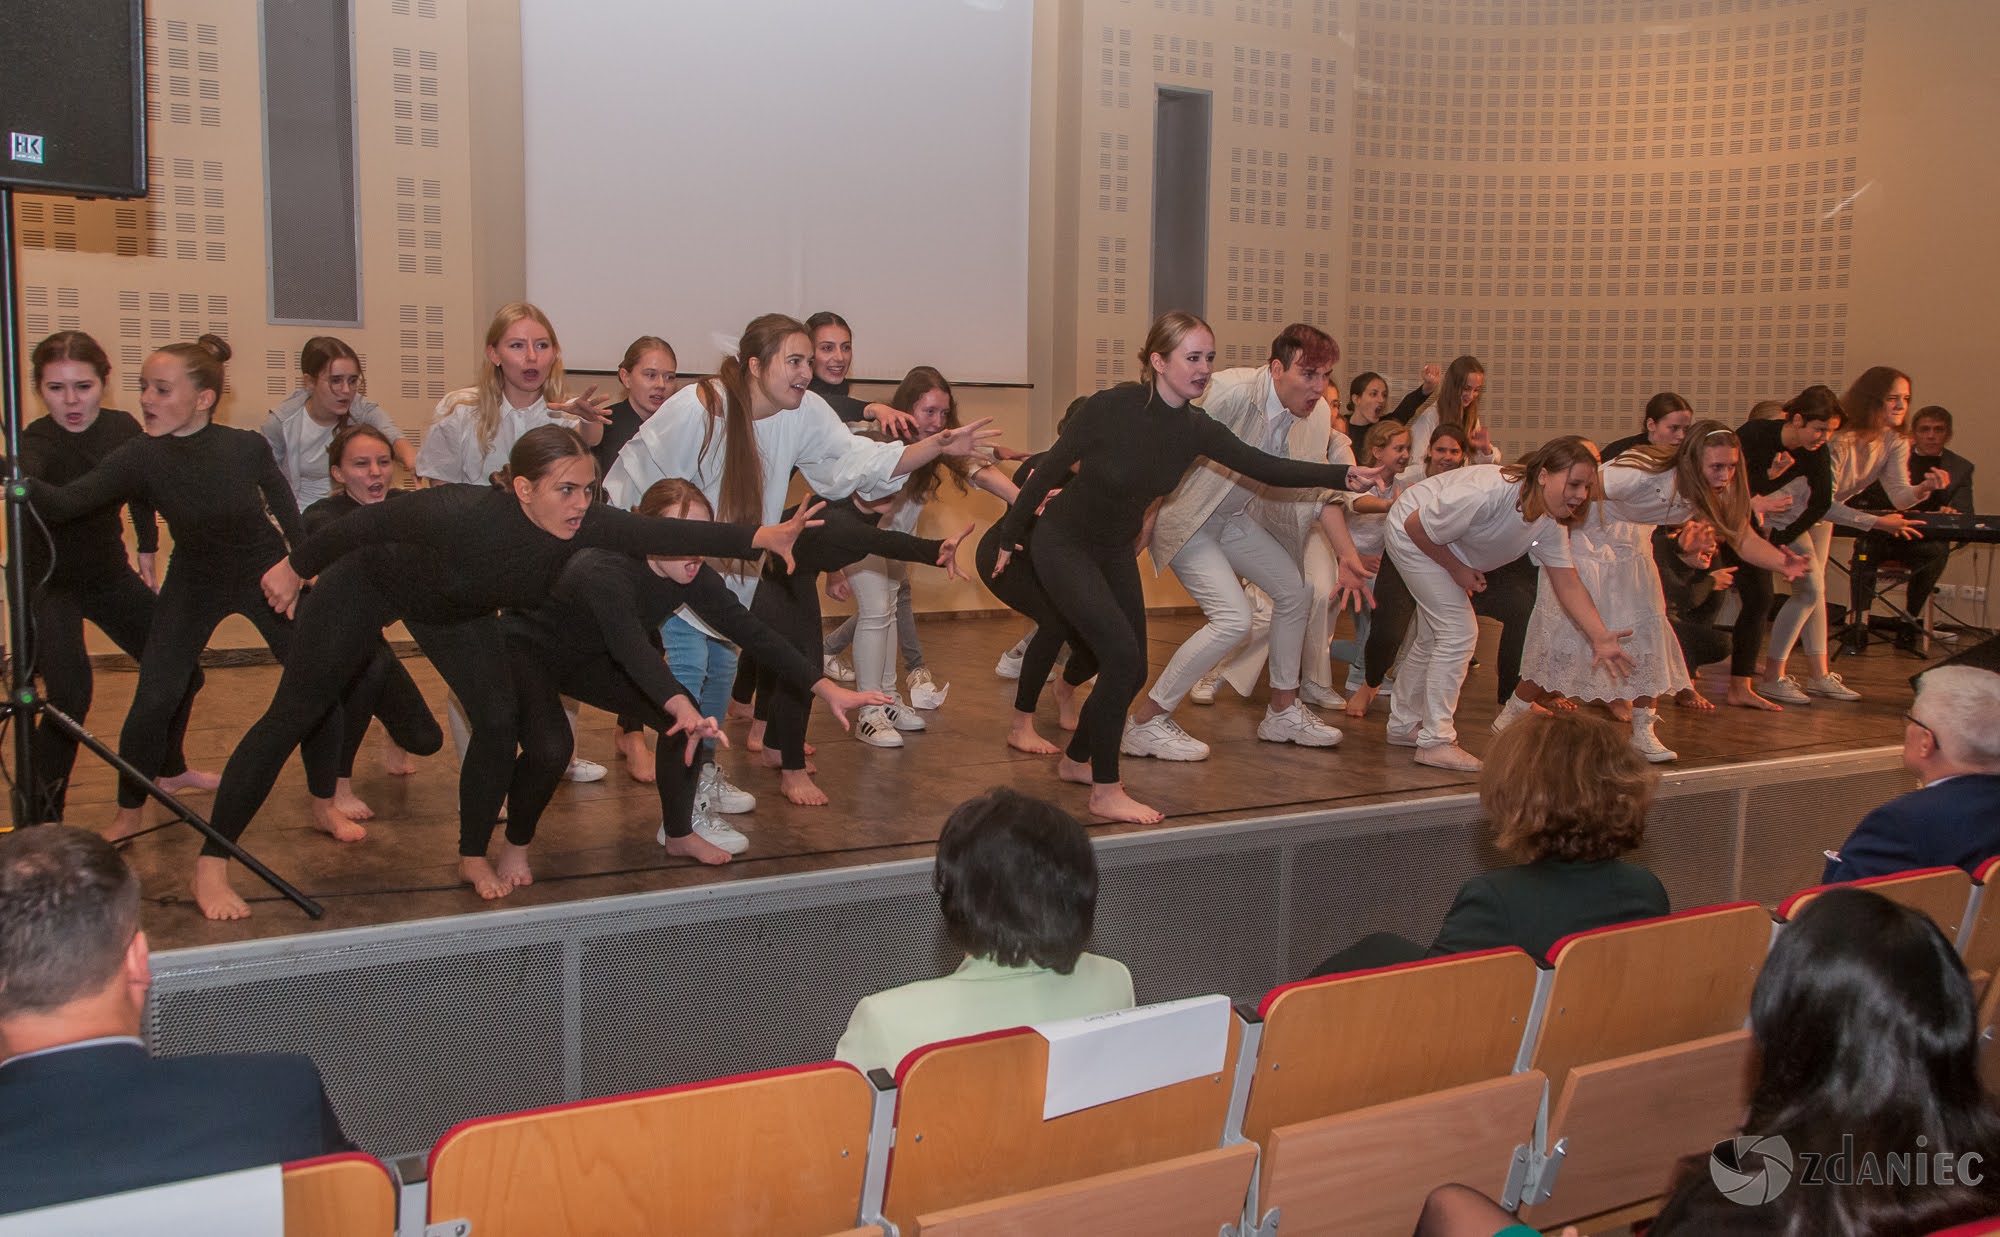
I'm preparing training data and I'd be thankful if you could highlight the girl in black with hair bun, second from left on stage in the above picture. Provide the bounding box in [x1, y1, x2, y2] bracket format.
[28, 334, 348, 841]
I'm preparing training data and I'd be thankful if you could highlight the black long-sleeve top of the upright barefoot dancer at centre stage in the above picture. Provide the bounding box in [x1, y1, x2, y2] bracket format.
[1000, 382, 1348, 548]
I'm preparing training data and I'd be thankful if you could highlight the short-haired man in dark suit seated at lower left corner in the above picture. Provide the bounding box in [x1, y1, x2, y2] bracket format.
[0, 825, 350, 1213]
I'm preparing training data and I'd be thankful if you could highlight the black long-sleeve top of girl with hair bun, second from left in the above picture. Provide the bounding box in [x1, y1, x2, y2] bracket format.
[28, 424, 302, 576]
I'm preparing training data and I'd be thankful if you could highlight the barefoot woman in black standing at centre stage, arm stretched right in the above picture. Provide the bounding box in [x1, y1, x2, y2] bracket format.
[994, 310, 1380, 825]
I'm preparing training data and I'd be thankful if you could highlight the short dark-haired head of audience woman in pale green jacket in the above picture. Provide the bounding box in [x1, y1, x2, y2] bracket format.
[932, 789, 1098, 975]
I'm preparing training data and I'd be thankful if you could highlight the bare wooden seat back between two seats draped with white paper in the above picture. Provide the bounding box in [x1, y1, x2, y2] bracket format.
[430, 1063, 872, 1237]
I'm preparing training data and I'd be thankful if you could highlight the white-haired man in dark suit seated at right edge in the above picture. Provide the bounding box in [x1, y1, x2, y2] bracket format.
[1822, 667, 2000, 883]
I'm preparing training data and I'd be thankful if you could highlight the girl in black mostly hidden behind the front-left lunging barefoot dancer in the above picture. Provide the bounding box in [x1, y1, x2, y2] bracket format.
[300, 422, 444, 821]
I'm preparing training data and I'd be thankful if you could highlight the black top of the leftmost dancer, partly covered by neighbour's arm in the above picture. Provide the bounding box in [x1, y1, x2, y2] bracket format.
[20, 408, 160, 588]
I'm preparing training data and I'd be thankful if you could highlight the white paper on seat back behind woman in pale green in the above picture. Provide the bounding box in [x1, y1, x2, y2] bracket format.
[1034, 997, 1230, 1121]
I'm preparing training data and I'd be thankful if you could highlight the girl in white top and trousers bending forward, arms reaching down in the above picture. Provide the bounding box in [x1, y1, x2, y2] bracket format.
[1388, 434, 1632, 773]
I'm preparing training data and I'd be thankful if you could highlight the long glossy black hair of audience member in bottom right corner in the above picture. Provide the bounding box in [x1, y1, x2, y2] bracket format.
[1744, 889, 2000, 1233]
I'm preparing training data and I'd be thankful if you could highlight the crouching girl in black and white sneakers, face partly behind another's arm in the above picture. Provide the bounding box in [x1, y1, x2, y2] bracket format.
[506, 476, 886, 863]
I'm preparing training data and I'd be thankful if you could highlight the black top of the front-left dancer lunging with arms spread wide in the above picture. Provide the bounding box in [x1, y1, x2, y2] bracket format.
[292, 478, 758, 623]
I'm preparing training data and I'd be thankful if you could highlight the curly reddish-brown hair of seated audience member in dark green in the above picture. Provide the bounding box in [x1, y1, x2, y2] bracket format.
[1480, 709, 1654, 863]
